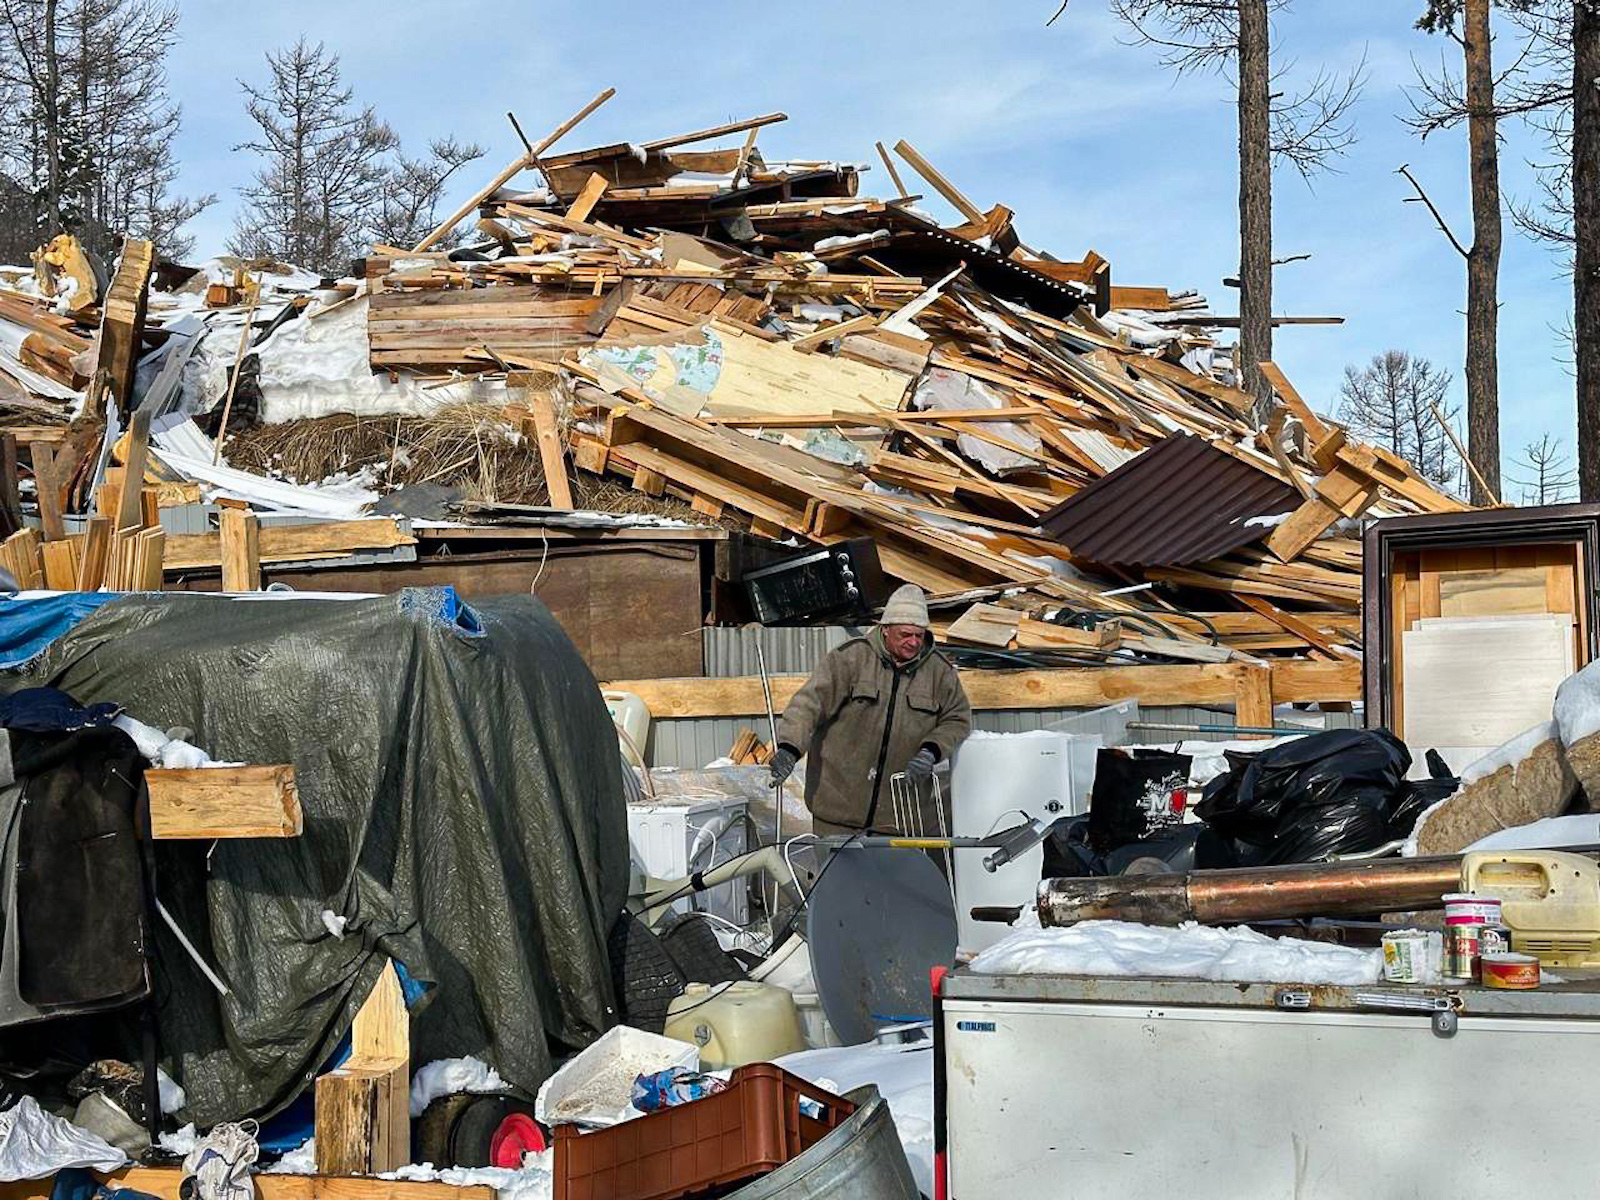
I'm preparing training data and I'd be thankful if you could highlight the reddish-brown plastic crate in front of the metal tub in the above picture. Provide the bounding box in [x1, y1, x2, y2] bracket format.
[554, 1062, 856, 1200]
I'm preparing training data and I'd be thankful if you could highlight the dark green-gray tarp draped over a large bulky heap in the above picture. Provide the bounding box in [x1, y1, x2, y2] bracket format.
[11, 589, 629, 1126]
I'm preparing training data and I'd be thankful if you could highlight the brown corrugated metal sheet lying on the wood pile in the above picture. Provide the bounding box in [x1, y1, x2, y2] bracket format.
[1038, 434, 1301, 566]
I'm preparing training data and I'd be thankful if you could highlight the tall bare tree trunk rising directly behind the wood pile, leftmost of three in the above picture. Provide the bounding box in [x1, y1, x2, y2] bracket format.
[1238, 0, 1272, 413]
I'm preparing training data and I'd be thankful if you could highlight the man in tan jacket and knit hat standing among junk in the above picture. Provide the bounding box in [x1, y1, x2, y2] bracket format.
[771, 584, 973, 834]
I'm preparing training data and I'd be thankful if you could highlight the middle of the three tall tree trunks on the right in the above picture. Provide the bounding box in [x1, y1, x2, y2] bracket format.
[1462, 0, 1501, 504]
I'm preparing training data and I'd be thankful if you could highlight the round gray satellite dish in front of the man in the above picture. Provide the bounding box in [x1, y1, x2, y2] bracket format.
[806, 846, 955, 1046]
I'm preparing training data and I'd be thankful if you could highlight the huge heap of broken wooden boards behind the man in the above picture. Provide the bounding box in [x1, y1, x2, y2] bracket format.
[360, 96, 1464, 661]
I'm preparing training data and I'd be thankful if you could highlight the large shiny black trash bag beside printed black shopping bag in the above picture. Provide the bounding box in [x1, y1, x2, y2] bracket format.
[1195, 730, 1411, 866]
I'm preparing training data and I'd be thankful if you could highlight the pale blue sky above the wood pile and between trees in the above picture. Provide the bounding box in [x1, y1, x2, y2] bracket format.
[168, 0, 1574, 474]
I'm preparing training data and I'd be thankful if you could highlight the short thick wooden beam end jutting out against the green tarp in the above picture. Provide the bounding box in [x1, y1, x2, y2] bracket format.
[144, 763, 304, 840]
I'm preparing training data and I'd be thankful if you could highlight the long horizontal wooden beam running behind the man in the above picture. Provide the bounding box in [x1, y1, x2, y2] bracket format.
[603, 659, 1362, 720]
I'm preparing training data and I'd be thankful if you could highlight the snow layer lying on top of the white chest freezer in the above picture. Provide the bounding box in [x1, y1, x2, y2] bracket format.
[970, 922, 1382, 986]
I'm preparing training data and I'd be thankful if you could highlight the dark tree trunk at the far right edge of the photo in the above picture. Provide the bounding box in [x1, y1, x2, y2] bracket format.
[1573, 0, 1600, 502]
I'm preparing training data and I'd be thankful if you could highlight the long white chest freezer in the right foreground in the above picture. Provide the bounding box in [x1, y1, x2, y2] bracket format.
[936, 971, 1600, 1200]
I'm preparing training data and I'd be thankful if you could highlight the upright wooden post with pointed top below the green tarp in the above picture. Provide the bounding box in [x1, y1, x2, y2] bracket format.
[315, 962, 411, 1174]
